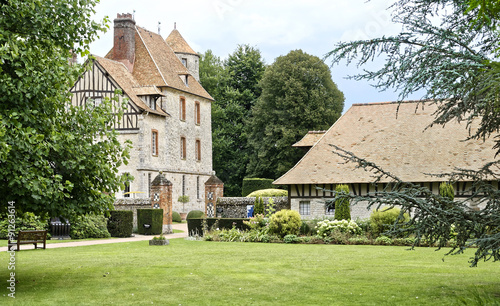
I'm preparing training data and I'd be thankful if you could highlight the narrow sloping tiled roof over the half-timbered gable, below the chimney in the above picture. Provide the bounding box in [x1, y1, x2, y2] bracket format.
[94, 55, 168, 116]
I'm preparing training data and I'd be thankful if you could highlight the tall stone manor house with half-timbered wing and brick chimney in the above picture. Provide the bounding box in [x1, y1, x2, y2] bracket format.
[71, 14, 213, 213]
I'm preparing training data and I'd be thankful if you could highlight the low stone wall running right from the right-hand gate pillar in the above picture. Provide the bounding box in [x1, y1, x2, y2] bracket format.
[217, 197, 290, 218]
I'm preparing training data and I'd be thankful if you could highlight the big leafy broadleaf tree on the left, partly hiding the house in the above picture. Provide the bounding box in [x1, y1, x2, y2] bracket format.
[0, 0, 131, 216]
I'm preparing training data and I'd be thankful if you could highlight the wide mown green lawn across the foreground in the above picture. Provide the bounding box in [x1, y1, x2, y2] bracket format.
[0, 239, 500, 305]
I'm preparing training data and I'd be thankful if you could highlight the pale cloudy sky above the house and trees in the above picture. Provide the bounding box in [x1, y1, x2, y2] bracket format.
[90, 0, 420, 111]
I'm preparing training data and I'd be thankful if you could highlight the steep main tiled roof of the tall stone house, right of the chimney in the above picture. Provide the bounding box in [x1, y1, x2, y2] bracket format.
[106, 27, 213, 100]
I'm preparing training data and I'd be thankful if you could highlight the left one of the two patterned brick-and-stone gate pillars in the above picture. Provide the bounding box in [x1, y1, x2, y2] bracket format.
[151, 172, 173, 234]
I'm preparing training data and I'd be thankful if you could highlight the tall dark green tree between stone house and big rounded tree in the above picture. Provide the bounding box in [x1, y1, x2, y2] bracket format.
[200, 45, 265, 196]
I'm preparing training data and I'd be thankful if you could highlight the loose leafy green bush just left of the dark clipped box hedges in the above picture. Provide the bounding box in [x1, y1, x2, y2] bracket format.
[69, 214, 111, 239]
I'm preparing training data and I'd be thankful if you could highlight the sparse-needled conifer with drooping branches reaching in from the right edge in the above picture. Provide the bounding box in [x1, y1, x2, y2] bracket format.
[330, 0, 500, 266]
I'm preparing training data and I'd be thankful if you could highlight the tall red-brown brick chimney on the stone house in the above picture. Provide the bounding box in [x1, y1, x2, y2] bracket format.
[113, 13, 135, 72]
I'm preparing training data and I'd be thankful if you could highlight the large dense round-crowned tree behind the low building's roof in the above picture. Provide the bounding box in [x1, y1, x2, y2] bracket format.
[248, 50, 344, 178]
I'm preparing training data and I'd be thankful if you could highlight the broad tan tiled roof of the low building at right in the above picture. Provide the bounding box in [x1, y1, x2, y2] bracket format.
[274, 101, 496, 185]
